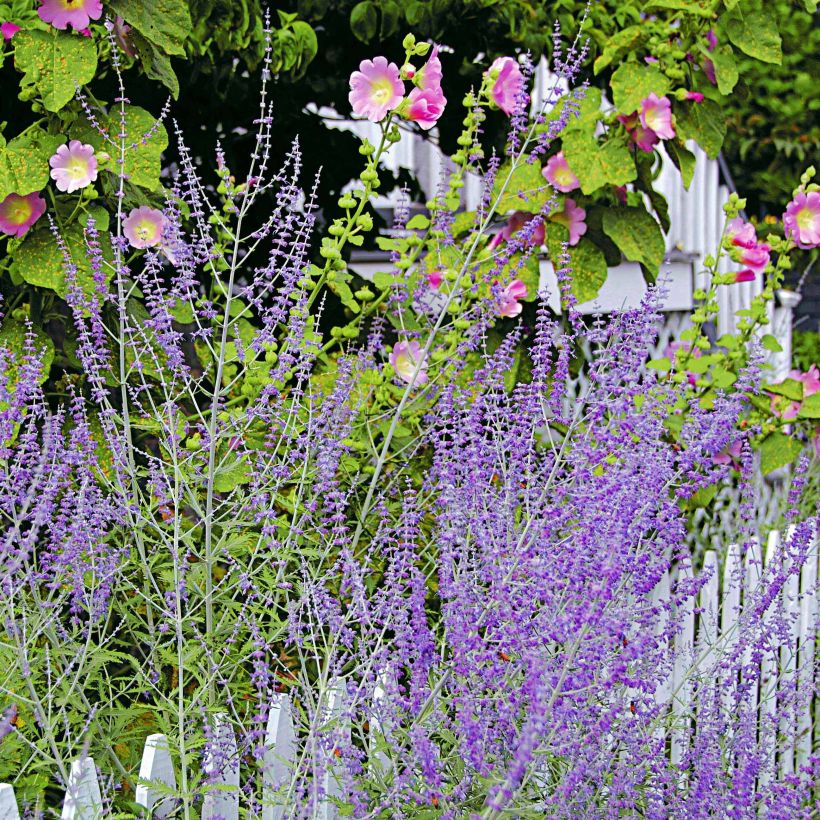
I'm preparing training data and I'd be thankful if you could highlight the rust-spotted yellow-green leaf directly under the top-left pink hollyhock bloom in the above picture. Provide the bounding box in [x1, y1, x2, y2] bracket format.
[14, 28, 97, 111]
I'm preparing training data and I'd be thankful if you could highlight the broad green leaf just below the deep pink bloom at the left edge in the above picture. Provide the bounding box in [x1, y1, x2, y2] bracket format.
[9, 225, 113, 299]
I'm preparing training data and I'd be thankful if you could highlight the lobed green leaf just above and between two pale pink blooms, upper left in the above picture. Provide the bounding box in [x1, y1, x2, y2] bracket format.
[71, 105, 168, 191]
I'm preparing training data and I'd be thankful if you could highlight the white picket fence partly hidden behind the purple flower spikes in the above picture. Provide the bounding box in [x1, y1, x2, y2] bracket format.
[0, 525, 820, 820]
